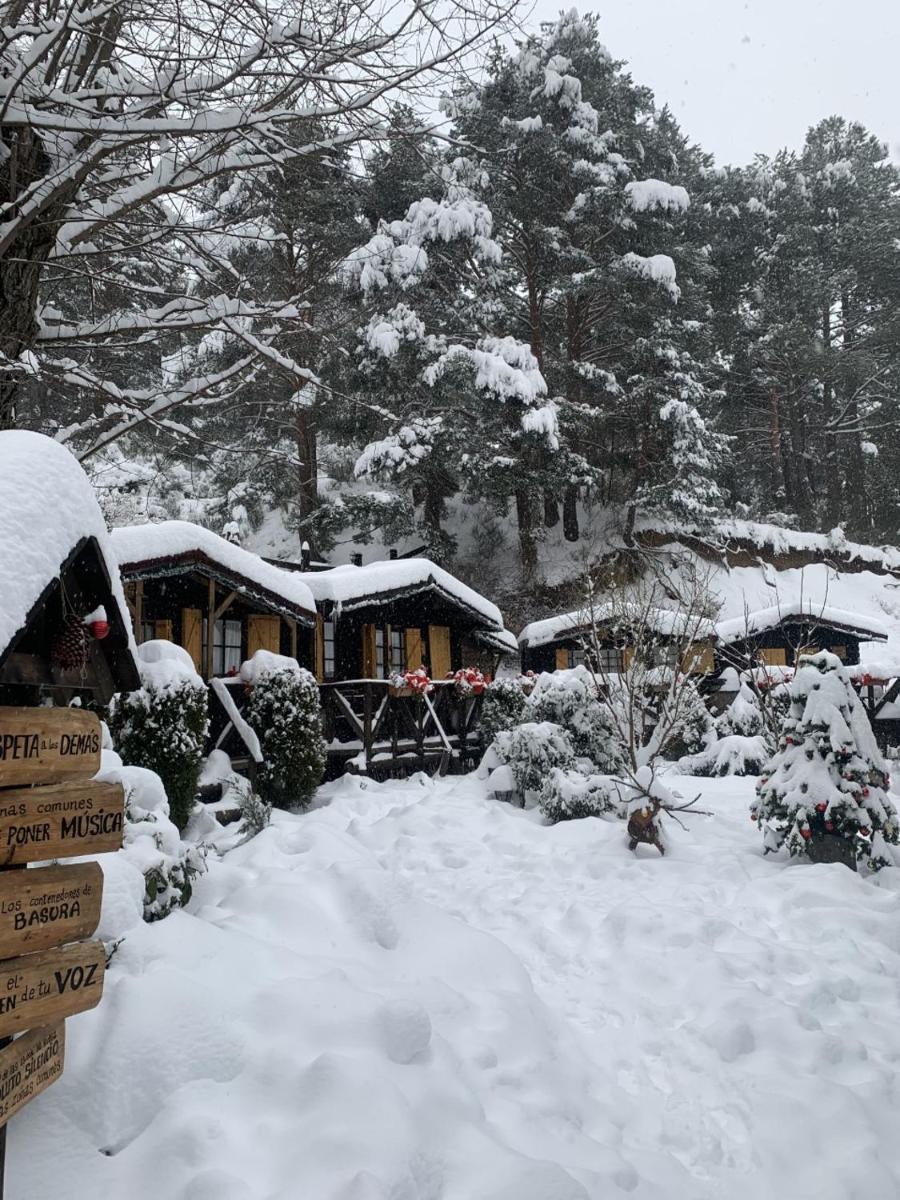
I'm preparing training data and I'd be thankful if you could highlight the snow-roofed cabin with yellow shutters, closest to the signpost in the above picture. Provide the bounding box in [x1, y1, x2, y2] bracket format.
[112, 521, 316, 679]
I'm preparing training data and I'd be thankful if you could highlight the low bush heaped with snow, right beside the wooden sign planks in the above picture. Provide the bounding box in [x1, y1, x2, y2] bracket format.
[97, 751, 206, 920]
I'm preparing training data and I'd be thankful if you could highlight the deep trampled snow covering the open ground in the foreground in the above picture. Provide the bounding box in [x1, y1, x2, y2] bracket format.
[7, 779, 900, 1200]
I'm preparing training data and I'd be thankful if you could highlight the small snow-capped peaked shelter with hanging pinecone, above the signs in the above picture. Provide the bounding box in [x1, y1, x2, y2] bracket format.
[0, 431, 140, 704]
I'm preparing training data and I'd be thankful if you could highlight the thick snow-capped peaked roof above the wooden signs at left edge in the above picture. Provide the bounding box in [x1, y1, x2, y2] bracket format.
[0, 430, 134, 654]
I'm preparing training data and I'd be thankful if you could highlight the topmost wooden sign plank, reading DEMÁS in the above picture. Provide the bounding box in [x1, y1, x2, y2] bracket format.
[0, 708, 101, 787]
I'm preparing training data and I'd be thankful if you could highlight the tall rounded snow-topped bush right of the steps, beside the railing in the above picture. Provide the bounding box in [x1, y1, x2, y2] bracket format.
[241, 650, 325, 809]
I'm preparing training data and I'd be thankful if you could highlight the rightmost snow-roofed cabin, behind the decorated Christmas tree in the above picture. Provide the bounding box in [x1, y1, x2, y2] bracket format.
[715, 600, 888, 671]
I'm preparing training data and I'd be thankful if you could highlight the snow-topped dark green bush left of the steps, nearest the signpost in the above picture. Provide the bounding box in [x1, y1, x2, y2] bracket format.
[109, 640, 209, 829]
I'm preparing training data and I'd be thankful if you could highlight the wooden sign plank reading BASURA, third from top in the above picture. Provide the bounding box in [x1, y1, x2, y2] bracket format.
[0, 863, 103, 959]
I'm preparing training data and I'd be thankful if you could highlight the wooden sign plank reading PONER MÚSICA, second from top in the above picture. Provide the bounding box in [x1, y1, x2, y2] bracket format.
[0, 782, 125, 866]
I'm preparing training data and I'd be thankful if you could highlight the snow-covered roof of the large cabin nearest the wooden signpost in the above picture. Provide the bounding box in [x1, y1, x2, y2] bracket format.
[112, 521, 316, 616]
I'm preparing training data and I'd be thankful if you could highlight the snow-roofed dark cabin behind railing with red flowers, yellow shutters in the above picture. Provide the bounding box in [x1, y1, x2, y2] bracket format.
[292, 558, 517, 683]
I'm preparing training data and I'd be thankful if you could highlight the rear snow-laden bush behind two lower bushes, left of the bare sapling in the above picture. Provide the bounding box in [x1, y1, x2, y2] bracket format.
[528, 666, 622, 773]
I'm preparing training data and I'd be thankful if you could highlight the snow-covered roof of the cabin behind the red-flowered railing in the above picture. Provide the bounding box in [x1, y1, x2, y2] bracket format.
[300, 558, 503, 630]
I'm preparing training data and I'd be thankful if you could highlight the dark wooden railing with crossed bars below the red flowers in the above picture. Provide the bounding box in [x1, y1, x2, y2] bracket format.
[320, 679, 481, 778]
